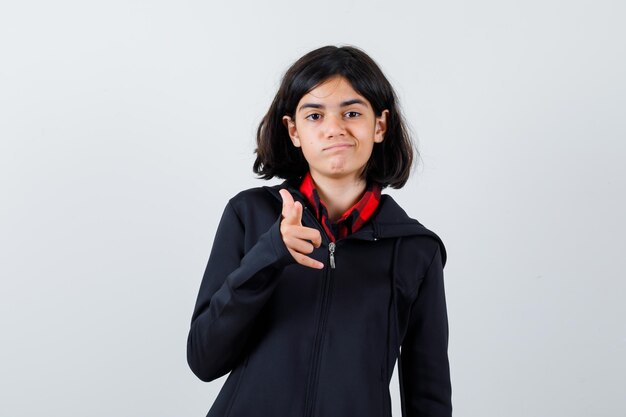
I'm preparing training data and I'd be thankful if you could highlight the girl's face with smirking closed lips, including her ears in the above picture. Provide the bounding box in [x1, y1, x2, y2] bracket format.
[283, 76, 389, 182]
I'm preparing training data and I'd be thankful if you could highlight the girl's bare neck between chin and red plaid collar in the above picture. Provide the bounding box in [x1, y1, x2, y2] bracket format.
[311, 172, 367, 221]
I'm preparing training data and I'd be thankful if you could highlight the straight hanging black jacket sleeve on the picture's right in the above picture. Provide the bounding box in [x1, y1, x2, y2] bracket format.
[398, 245, 452, 417]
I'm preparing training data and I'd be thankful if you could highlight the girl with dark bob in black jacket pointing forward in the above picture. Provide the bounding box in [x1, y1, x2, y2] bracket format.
[187, 46, 451, 417]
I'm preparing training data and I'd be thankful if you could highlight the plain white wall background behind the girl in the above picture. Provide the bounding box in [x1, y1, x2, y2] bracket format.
[0, 0, 626, 417]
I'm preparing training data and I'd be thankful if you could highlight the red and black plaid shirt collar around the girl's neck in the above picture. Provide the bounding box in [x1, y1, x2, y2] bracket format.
[300, 172, 381, 242]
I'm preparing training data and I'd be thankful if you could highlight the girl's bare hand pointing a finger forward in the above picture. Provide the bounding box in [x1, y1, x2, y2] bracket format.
[279, 189, 324, 269]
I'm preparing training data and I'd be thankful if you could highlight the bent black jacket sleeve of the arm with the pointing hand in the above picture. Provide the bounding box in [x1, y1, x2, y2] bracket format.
[187, 202, 293, 381]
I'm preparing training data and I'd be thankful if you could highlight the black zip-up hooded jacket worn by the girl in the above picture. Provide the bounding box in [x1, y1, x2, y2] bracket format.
[187, 182, 452, 417]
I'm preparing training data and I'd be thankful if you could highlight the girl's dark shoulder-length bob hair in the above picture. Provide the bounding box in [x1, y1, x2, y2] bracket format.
[253, 46, 413, 188]
